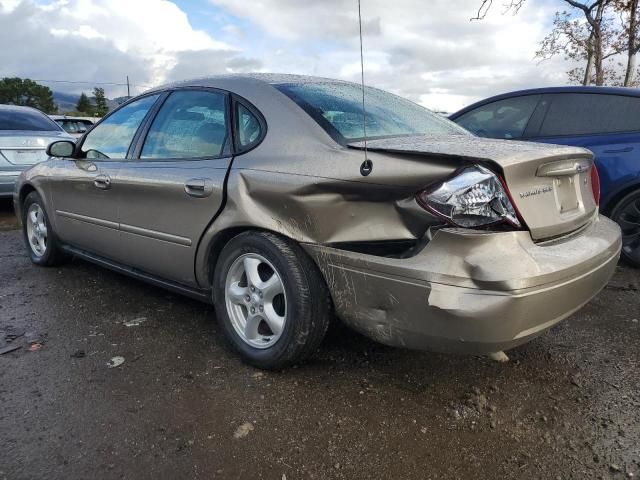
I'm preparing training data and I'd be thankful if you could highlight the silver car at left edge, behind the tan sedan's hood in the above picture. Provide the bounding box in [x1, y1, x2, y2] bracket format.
[0, 105, 70, 198]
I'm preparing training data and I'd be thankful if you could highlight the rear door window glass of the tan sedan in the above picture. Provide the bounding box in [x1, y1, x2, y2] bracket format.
[140, 91, 227, 158]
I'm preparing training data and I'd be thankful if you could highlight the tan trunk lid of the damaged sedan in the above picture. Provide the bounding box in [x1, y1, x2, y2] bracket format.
[349, 135, 598, 240]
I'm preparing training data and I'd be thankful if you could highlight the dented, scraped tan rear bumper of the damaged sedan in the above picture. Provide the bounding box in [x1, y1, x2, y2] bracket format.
[304, 217, 621, 354]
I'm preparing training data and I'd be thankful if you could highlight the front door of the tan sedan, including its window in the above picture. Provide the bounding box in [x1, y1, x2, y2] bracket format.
[49, 94, 159, 260]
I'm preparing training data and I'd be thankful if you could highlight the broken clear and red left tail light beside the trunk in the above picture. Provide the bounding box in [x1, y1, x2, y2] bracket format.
[416, 165, 522, 228]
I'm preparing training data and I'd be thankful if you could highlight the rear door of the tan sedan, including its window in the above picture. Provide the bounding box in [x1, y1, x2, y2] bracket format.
[114, 89, 232, 285]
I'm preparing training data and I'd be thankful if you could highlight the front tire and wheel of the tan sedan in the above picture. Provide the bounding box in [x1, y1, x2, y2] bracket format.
[22, 192, 68, 267]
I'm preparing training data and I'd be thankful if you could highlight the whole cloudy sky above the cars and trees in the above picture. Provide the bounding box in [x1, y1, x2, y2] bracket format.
[0, 0, 569, 112]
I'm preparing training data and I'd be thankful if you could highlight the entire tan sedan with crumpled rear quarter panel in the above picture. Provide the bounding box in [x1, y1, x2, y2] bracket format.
[14, 75, 621, 368]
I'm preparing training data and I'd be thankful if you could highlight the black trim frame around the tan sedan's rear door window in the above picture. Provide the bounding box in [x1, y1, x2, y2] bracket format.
[130, 87, 233, 163]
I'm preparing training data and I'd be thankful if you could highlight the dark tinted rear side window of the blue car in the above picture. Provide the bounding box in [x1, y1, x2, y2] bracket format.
[538, 93, 640, 137]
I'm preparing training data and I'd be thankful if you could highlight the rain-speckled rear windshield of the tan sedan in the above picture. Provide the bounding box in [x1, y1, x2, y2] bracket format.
[275, 82, 469, 143]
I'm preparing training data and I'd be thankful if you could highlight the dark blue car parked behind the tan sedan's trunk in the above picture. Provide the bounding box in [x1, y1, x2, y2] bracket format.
[450, 87, 640, 267]
